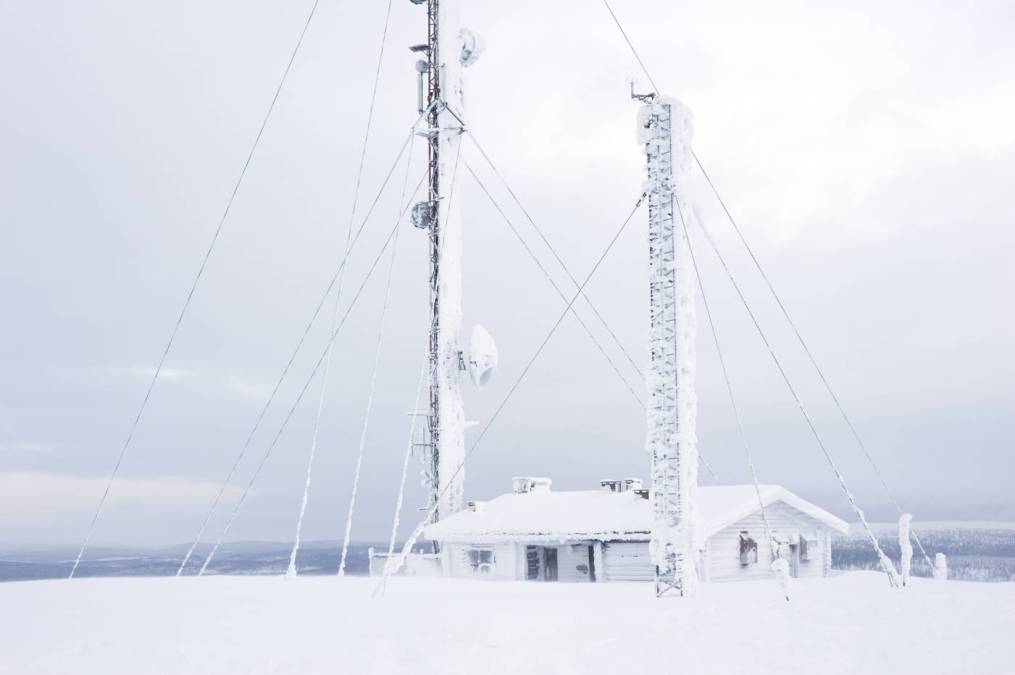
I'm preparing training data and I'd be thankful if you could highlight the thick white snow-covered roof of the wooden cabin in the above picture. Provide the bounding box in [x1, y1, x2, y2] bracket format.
[423, 485, 849, 541]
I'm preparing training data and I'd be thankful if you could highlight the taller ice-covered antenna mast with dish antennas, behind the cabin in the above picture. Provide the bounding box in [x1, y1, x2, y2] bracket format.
[410, 0, 487, 520]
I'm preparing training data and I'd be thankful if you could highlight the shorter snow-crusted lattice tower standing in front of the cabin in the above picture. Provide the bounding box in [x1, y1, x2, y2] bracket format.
[637, 94, 698, 595]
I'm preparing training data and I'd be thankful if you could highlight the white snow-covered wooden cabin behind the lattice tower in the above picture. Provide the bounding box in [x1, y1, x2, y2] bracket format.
[423, 477, 849, 582]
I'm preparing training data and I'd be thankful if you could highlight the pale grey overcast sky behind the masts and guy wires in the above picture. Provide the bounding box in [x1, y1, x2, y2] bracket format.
[0, 0, 1015, 545]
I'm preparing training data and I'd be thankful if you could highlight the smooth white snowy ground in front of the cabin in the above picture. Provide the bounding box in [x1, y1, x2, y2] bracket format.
[0, 572, 1015, 675]
